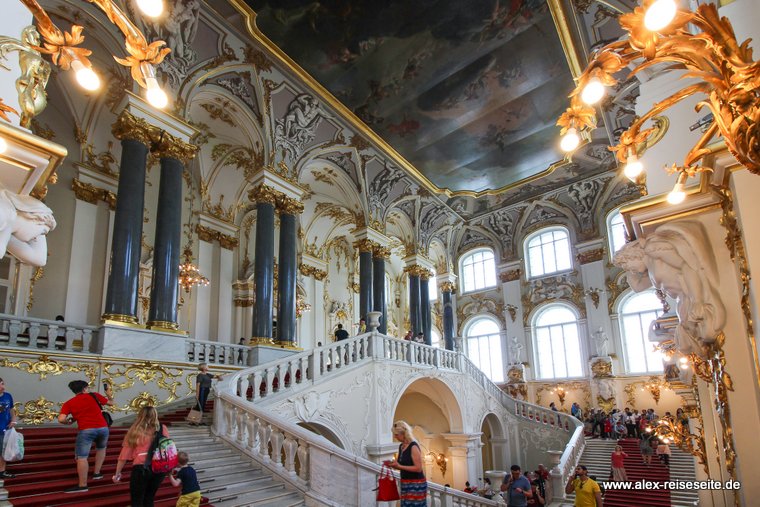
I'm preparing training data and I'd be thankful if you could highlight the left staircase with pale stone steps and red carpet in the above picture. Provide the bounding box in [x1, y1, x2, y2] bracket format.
[4, 402, 304, 507]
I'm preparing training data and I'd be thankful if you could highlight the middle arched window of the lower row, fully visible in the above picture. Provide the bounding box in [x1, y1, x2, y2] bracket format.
[533, 304, 583, 379]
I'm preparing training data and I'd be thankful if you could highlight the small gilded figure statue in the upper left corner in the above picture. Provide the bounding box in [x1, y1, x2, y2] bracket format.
[0, 25, 50, 128]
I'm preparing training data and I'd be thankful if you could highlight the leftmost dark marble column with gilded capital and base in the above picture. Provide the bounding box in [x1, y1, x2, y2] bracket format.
[103, 112, 151, 323]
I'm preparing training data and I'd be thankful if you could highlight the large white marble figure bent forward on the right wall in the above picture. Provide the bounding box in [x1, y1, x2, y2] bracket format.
[614, 222, 726, 354]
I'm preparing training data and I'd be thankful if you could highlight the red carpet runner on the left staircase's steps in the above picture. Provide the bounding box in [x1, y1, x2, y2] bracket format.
[5, 402, 213, 507]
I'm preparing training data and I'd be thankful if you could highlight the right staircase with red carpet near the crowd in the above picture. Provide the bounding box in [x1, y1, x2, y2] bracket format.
[568, 438, 699, 507]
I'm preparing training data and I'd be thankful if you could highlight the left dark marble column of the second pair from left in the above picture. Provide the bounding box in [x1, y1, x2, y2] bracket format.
[248, 185, 278, 345]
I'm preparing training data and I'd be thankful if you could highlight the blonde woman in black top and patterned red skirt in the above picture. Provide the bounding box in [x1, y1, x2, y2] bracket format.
[384, 421, 427, 507]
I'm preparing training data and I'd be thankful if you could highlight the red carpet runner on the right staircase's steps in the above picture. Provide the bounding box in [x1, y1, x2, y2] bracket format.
[598, 438, 671, 507]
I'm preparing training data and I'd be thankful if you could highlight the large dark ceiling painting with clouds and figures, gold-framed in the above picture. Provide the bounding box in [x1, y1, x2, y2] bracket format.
[247, 0, 573, 191]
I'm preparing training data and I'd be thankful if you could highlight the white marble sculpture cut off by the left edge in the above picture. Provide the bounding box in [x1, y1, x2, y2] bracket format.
[0, 188, 56, 266]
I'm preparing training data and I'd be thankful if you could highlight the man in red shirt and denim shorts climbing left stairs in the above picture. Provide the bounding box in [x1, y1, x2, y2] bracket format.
[58, 380, 113, 493]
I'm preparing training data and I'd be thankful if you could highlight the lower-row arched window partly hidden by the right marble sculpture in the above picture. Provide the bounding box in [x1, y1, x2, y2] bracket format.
[620, 290, 662, 373]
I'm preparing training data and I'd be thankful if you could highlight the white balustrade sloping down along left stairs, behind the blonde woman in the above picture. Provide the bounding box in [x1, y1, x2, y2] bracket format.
[211, 384, 499, 507]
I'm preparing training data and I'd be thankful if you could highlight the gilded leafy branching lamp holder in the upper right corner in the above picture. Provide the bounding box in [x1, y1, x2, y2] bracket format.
[557, 0, 760, 185]
